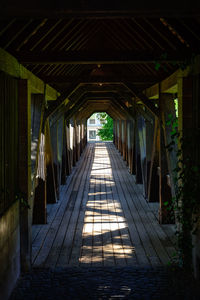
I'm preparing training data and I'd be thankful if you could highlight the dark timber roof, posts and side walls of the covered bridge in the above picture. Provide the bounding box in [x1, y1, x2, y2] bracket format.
[0, 1, 200, 299]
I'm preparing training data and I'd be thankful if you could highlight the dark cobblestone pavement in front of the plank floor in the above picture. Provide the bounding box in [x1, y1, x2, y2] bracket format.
[10, 267, 200, 300]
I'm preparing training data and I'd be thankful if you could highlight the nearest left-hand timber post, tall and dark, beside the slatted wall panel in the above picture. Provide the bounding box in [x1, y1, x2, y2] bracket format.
[19, 79, 33, 271]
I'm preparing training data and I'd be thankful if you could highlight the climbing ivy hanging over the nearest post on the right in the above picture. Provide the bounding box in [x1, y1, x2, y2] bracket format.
[164, 115, 200, 270]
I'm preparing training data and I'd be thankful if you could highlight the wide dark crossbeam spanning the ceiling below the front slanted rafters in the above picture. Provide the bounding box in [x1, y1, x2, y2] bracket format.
[16, 49, 188, 65]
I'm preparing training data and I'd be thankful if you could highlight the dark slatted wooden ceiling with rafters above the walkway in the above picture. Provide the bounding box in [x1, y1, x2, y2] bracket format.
[0, 1, 200, 118]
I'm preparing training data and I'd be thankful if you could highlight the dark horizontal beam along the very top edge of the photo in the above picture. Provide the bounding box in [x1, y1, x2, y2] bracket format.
[0, 0, 199, 19]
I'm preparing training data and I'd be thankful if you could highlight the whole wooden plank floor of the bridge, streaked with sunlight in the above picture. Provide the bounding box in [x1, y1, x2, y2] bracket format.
[32, 142, 176, 267]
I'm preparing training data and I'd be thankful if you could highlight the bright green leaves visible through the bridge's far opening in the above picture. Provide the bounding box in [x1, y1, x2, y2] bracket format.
[98, 113, 113, 141]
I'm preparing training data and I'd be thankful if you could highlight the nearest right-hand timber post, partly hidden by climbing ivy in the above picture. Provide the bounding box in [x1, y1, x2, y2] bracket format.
[178, 77, 195, 266]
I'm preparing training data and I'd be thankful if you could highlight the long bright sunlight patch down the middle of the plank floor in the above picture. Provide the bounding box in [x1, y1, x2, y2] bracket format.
[80, 147, 135, 265]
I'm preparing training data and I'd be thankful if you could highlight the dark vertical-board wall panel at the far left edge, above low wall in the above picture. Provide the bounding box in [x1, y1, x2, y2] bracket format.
[0, 73, 18, 214]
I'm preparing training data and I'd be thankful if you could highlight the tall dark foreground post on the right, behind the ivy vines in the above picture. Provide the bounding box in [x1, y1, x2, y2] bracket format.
[178, 77, 194, 268]
